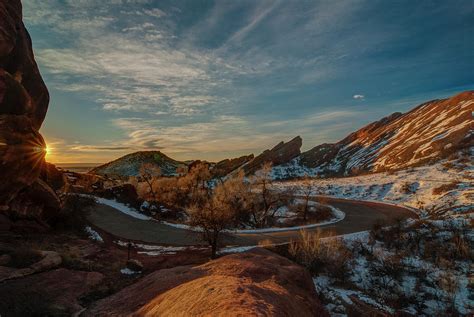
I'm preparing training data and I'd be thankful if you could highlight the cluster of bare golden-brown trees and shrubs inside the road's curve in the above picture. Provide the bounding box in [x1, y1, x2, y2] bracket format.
[130, 162, 334, 257]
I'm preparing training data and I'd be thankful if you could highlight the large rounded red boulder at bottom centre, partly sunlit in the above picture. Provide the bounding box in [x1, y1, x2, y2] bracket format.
[85, 249, 327, 316]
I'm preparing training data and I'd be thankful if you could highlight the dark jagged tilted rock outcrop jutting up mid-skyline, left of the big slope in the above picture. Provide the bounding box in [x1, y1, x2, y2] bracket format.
[243, 136, 303, 174]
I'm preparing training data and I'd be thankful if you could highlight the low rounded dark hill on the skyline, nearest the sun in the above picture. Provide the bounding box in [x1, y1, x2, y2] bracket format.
[89, 151, 186, 177]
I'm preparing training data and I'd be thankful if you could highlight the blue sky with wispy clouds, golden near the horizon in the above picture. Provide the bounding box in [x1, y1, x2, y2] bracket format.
[23, 0, 474, 163]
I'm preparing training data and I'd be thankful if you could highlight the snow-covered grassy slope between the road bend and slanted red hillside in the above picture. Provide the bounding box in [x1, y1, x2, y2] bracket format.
[275, 160, 474, 215]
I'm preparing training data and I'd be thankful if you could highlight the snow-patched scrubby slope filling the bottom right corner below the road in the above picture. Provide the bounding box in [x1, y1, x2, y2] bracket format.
[287, 218, 474, 316]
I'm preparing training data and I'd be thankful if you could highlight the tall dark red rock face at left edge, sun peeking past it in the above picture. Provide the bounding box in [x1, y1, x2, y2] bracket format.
[0, 0, 57, 215]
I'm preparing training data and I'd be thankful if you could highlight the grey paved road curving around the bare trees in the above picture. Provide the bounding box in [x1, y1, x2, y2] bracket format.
[88, 197, 417, 246]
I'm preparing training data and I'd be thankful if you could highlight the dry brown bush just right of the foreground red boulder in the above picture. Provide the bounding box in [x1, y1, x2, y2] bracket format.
[288, 230, 353, 282]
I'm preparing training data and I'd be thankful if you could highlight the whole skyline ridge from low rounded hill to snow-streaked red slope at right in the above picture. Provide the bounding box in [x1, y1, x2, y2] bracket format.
[90, 91, 474, 177]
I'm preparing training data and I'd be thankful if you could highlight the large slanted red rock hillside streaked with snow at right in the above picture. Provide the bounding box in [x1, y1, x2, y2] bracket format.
[294, 91, 474, 175]
